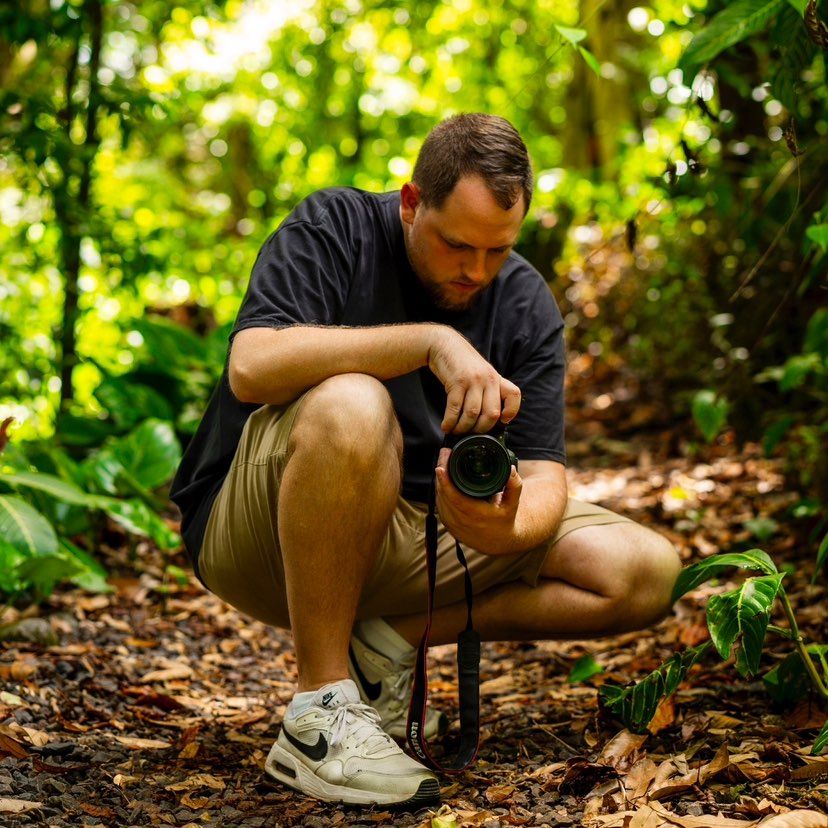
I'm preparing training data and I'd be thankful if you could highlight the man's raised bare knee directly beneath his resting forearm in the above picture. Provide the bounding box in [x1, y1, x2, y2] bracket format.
[288, 374, 403, 464]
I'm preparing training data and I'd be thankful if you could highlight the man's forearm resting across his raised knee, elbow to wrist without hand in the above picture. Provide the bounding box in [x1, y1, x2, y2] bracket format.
[229, 323, 441, 405]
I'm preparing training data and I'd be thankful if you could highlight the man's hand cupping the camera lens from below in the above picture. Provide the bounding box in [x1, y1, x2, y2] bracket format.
[435, 448, 523, 555]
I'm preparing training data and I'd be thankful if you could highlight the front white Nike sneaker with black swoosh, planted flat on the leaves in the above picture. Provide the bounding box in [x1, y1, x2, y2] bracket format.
[265, 679, 440, 808]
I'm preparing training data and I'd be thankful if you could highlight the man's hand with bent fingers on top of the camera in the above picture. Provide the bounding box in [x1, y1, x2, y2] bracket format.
[428, 325, 520, 434]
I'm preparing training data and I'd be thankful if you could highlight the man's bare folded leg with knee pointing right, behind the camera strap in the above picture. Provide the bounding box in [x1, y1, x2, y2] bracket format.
[385, 523, 681, 646]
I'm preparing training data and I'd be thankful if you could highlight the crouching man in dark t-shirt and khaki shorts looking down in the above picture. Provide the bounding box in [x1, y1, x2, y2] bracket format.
[172, 114, 679, 806]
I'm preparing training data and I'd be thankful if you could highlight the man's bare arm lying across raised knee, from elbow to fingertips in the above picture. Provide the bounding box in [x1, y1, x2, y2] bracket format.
[229, 323, 520, 434]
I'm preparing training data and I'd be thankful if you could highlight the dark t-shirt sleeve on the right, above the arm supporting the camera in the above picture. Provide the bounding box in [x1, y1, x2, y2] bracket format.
[506, 284, 566, 464]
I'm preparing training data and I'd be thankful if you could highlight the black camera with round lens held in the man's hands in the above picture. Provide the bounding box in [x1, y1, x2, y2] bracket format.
[448, 432, 518, 499]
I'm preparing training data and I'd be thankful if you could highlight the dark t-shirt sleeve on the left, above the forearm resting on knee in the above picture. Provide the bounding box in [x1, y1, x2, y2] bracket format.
[230, 220, 354, 340]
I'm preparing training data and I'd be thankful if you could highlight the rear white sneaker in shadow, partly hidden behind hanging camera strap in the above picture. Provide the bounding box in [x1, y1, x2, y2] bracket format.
[348, 634, 448, 739]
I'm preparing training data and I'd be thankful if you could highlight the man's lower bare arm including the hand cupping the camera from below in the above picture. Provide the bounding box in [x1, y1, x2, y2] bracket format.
[436, 449, 567, 555]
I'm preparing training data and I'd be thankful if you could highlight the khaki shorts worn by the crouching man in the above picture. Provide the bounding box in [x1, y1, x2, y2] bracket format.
[199, 397, 632, 627]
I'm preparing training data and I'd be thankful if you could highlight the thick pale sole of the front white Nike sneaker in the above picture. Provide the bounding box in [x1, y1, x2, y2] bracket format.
[265, 743, 440, 809]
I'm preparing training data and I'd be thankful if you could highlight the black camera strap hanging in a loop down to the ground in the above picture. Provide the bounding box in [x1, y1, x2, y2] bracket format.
[406, 462, 480, 773]
